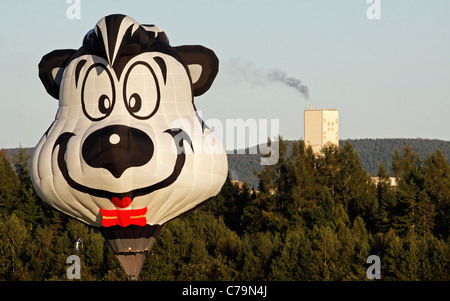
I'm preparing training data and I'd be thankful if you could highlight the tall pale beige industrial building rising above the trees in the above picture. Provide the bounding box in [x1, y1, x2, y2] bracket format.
[304, 105, 339, 153]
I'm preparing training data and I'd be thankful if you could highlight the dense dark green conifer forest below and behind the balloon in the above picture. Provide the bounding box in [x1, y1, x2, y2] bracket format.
[0, 138, 450, 281]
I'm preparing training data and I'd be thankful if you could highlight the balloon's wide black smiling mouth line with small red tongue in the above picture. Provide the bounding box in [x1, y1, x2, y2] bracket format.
[53, 129, 194, 208]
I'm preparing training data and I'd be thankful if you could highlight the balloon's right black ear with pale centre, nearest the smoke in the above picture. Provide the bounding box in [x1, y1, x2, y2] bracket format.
[173, 45, 219, 96]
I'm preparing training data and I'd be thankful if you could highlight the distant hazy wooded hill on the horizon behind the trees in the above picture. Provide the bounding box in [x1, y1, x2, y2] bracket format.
[2, 138, 450, 189]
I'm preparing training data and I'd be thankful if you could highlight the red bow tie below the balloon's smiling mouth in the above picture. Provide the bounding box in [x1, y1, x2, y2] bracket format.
[100, 207, 147, 227]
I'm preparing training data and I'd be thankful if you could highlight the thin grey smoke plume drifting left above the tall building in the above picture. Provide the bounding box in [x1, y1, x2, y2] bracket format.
[224, 58, 309, 100]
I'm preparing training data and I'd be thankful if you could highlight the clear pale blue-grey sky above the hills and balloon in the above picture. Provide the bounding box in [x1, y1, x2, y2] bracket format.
[0, 0, 450, 148]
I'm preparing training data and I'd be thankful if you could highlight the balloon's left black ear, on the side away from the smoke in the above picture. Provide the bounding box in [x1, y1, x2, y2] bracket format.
[38, 49, 76, 99]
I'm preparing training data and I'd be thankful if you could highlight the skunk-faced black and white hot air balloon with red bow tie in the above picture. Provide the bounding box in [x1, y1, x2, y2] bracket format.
[31, 14, 228, 279]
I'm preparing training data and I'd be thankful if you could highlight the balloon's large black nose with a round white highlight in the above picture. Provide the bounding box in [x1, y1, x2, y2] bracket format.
[82, 125, 154, 178]
